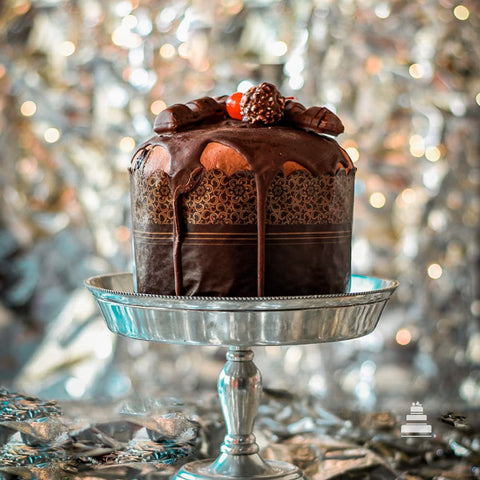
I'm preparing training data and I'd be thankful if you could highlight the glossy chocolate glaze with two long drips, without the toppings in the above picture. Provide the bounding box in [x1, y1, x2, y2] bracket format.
[132, 118, 351, 296]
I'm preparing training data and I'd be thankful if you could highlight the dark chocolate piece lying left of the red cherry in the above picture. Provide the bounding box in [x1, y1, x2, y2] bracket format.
[153, 97, 226, 133]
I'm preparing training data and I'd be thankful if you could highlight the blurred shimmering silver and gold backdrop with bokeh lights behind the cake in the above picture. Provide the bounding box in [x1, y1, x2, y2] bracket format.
[0, 0, 480, 411]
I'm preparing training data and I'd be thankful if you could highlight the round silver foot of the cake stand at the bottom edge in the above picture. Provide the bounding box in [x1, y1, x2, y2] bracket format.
[175, 459, 305, 480]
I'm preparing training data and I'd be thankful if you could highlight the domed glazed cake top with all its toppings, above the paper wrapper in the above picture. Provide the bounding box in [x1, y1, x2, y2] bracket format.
[130, 83, 354, 179]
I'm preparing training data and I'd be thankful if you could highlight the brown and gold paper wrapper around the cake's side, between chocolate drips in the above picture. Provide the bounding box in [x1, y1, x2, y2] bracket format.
[131, 169, 355, 296]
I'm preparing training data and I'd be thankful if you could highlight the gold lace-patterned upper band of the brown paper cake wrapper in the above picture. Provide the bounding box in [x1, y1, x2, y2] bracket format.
[134, 170, 354, 225]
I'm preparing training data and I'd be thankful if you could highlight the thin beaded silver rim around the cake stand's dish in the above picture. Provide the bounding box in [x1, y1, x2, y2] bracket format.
[84, 271, 399, 311]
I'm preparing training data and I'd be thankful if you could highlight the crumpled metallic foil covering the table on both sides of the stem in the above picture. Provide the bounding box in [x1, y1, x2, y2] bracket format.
[0, 389, 480, 480]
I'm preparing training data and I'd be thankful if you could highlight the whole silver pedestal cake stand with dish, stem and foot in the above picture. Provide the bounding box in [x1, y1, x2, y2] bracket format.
[85, 273, 397, 480]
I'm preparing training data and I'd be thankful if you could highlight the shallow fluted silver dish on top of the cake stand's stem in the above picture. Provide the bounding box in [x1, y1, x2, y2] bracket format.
[85, 273, 398, 347]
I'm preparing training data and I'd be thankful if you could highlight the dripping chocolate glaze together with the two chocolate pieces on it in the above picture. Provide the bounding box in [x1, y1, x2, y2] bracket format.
[130, 86, 355, 296]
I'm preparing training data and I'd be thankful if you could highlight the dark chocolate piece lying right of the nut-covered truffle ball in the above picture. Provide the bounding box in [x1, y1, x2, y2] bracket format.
[284, 100, 344, 136]
